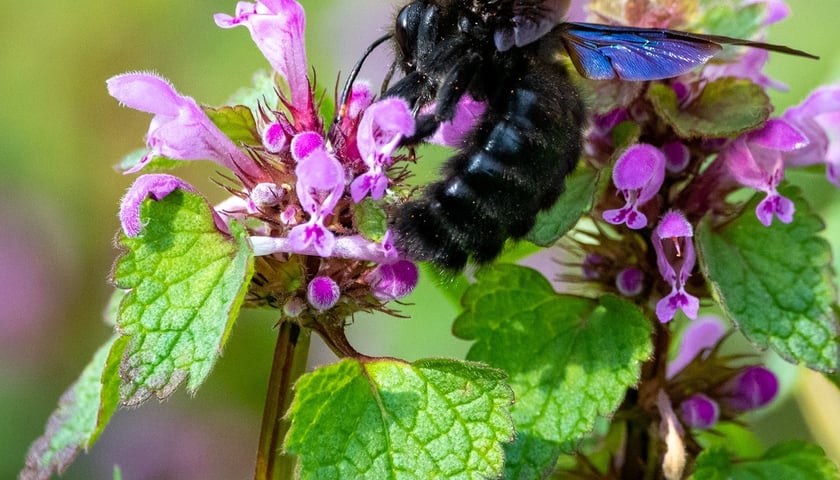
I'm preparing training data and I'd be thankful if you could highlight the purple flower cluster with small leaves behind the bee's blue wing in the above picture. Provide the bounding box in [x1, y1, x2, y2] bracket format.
[574, 0, 840, 323]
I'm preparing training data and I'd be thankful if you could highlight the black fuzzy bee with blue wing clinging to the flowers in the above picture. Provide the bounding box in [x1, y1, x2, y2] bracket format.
[376, 0, 810, 270]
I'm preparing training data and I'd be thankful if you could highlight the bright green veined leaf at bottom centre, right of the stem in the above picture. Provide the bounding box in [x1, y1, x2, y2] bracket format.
[285, 359, 514, 479]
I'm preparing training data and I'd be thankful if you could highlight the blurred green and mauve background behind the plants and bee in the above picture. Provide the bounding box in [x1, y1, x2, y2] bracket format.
[0, 0, 840, 480]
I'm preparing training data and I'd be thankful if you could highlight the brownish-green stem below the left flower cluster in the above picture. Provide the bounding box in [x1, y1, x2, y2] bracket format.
[254, 320, 309, 480]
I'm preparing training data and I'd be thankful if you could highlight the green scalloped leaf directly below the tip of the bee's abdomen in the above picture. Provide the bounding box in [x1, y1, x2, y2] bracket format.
[453, 265, 652, 478]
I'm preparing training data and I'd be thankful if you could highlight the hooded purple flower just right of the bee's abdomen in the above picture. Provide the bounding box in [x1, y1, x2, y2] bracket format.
[603, 143, 665, 230]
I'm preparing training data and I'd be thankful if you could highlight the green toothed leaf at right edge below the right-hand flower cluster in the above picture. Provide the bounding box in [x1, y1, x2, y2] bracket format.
[697, 188, 840, 372]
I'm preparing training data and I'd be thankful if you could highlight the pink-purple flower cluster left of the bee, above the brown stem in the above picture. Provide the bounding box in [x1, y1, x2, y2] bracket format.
[112, 0, 418, 330]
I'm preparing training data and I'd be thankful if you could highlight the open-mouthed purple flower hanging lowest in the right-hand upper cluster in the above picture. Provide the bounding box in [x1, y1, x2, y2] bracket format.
[652, 211, 700, 323]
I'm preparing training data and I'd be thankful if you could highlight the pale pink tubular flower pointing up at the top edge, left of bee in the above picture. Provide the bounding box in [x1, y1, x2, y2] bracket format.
[213, 0, 314, 118]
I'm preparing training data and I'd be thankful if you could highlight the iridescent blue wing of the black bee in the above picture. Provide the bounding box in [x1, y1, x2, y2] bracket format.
[555, 22, 817, 80]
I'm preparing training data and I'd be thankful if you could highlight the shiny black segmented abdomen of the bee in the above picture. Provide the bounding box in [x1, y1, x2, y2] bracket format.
[395, 59, 583, 270]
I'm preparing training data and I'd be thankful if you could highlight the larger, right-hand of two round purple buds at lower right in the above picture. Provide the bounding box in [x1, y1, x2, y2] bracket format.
[719, 365, 779, 412]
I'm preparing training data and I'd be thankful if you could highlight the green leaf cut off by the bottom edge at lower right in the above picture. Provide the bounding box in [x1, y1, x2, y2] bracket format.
[694, 441, 838, 480]
